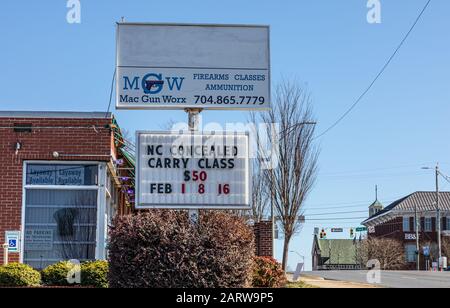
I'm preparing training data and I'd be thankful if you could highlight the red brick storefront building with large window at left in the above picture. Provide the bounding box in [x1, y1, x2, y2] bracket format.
[0, 111, 133, 268]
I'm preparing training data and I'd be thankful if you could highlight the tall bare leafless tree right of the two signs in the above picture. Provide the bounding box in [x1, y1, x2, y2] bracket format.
[261, 82, 319, 269]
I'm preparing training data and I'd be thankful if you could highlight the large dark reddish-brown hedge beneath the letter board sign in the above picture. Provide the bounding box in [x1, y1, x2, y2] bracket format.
[109, 210, 254, 288]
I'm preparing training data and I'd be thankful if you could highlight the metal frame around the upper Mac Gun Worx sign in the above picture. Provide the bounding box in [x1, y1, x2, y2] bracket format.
[115, 22, 272, 111]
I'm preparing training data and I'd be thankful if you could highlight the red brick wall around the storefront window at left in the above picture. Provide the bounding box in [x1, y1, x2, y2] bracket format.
[0, 118, 113, 263]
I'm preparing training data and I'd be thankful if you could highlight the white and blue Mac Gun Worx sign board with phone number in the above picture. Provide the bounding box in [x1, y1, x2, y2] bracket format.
[116, 23, 270, 110]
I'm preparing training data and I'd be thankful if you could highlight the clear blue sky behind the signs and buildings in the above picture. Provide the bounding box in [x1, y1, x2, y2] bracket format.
[0, 0, 450, 267]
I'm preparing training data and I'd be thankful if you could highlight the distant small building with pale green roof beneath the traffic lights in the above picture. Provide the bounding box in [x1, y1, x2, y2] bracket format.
[312, 234, 361, 271]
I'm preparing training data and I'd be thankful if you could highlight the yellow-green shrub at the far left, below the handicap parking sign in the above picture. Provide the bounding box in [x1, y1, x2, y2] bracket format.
[0, 263, 41, 287]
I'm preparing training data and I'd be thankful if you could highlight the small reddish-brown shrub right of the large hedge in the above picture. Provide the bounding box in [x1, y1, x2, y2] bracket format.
[253, 257, 287, 288]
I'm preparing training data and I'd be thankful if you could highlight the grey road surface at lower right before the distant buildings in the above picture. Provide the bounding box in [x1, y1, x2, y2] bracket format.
[302, 271, 450, 288]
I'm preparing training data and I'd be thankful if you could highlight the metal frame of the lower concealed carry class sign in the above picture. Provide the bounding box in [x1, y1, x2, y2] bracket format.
[135, 131, 253, 210]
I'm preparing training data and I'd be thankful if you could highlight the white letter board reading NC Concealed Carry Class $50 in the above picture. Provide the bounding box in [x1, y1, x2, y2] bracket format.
[136, 132, 251, 209]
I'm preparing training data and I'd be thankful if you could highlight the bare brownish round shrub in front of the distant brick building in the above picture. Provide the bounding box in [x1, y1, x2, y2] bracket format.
[356, 238, 406, 270]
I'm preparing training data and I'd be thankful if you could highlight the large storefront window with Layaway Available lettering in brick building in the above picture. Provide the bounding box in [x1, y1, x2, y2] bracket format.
[23, 164, 98, 269]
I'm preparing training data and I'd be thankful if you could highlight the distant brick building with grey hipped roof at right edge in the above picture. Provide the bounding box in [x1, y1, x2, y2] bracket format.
[362, 192, 450, 269]
